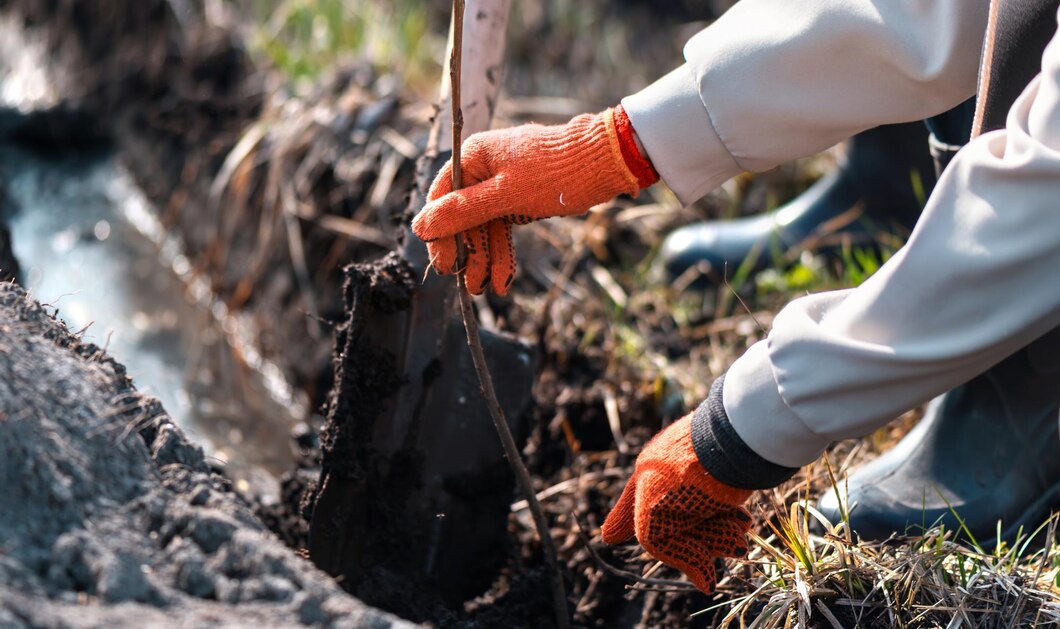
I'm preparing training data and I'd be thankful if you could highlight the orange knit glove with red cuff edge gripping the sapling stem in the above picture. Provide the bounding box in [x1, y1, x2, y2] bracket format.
[412, 106, 658, 295]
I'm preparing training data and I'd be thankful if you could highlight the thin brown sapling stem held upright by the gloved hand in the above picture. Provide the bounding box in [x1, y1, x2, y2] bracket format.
[449, 0, 570, 629]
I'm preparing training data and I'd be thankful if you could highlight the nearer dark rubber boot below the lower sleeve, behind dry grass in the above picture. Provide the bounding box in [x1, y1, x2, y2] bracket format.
[818, 330, 1060, 547]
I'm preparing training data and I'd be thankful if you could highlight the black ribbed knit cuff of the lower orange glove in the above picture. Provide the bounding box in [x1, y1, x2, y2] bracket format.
[692, 375, 798, 489]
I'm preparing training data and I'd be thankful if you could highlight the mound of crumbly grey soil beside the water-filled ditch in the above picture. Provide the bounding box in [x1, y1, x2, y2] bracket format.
[0, 283, 408, 628]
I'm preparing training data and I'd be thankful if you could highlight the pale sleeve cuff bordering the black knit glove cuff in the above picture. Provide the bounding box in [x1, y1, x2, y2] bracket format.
[722, 340, 831, 468]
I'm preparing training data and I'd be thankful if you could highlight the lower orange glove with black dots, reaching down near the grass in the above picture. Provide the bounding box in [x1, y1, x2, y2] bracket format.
[602, 414, 752, 594]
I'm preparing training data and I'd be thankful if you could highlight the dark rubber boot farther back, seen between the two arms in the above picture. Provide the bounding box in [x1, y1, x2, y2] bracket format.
[659, 122, 935, 281]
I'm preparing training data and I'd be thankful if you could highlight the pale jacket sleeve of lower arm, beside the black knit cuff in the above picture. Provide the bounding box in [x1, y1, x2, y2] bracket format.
[723, 12, 1060, 467]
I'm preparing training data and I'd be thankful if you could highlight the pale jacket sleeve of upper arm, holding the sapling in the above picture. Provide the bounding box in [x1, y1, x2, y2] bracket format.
[622, 0, 990, 204]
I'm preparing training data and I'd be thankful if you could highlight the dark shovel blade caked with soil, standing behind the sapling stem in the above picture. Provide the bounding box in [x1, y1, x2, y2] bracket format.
[300, 254, 532, 622]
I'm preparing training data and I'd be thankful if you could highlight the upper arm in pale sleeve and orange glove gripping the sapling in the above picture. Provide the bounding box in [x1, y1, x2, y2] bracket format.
[412, 0, 988, 294]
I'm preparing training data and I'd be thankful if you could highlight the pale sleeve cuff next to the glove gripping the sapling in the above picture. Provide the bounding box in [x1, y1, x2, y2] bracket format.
[622, 65, 743, 205]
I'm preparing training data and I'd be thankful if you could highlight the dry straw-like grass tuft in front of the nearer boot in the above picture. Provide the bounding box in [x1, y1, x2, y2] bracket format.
[701, 502, 1060, 629]
